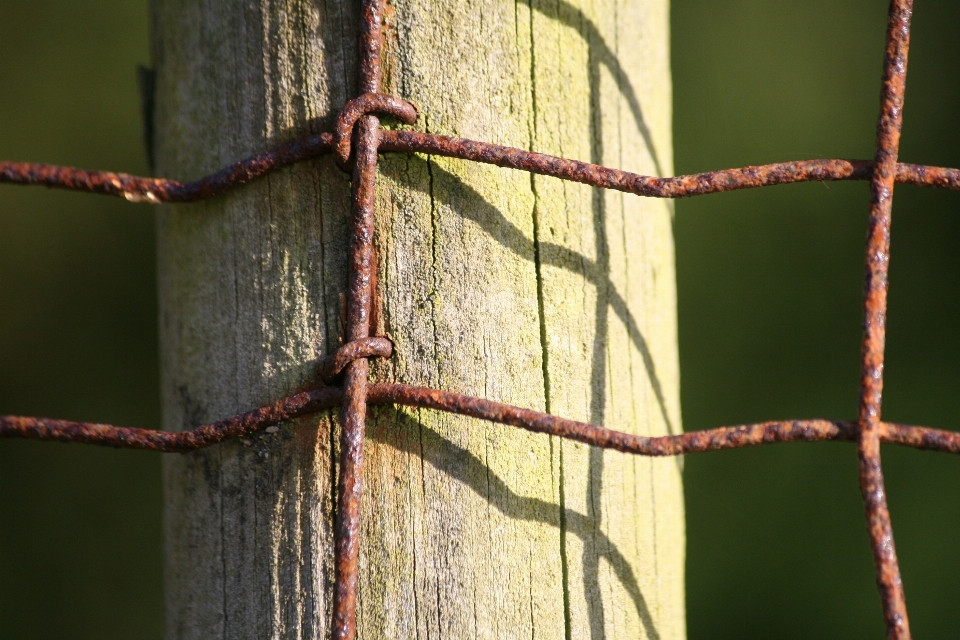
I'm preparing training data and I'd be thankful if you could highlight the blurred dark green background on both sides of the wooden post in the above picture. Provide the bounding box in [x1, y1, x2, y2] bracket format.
[0, 0, 960, 640]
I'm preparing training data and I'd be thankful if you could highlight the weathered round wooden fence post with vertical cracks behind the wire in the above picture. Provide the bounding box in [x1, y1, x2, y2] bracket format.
[153, 0, 685, 639]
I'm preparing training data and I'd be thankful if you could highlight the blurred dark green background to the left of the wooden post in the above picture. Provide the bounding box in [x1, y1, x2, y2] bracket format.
[0, 0, 162, 640]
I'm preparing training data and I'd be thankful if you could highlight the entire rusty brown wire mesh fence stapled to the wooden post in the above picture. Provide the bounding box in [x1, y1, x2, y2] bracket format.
[0, 0, 960, 640]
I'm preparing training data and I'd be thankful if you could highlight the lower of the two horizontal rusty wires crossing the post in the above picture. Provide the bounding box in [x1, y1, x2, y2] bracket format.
[9, 383, 960, 456]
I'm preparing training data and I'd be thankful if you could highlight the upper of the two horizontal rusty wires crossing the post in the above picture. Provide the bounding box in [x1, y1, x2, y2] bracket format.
[0, 136, 960, 204]
